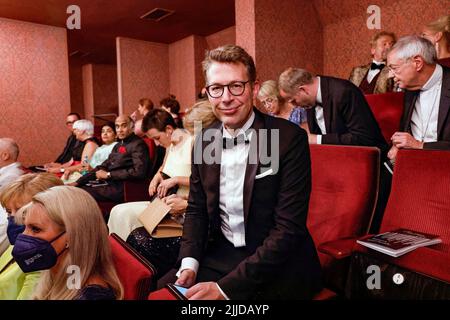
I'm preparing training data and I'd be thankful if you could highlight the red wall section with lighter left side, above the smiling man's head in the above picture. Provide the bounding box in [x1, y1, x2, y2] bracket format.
[236, 0, 323, 81]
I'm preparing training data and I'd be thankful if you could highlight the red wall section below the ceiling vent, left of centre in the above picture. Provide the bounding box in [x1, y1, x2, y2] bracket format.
[116, 37, 169, 114]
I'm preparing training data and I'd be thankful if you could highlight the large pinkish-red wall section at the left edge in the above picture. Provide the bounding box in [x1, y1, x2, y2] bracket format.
[0, 18, 70, 165]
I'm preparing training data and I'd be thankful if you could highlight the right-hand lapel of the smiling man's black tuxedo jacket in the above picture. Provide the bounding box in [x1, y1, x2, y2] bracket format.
[243, 109, 264, 225]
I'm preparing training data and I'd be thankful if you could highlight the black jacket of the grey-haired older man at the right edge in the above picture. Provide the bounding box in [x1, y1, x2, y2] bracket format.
[400, 67, 450, 150]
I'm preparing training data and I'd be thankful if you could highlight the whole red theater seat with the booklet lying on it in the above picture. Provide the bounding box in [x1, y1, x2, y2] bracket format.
[348, 150, 450, 299]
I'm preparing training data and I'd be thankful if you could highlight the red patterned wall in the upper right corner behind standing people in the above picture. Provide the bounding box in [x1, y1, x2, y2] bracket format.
[314, 0, 450, 78]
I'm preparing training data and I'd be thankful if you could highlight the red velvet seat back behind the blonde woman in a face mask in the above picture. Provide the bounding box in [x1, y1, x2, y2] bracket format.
[109, 233, 155, 300]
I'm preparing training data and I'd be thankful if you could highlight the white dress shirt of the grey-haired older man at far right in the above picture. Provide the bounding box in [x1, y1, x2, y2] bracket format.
[411, 64, 443, 142]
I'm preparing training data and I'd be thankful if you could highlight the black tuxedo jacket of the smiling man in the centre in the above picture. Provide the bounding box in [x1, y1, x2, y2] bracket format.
[178, 109, 320, 299]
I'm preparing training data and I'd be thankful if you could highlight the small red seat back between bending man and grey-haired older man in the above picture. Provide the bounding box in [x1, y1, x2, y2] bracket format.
[365, 92, 403, 141]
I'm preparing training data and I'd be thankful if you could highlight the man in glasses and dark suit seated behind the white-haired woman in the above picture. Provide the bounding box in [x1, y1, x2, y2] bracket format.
[45, 112, 84, 168]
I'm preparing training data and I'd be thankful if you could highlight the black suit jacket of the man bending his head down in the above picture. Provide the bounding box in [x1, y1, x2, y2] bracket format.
[307, 76, 388, 152]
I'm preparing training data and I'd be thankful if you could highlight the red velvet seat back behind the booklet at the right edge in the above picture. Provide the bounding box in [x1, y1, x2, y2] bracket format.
[380, 150, 450, 252]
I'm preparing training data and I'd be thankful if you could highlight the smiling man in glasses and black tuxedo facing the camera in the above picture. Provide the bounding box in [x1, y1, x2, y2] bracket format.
[158, 45, 321, 299]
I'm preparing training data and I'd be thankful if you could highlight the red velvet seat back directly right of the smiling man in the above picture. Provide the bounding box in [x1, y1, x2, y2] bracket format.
[307, 145, 379, 268]
